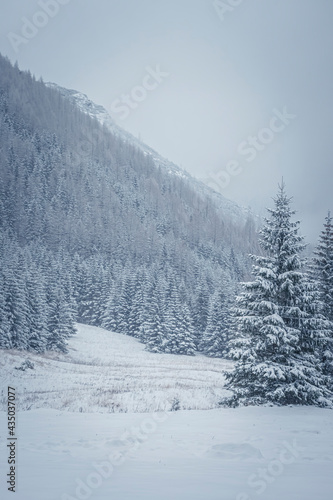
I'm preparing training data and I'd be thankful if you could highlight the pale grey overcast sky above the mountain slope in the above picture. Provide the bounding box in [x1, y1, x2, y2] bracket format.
[0, 0, 333, 241]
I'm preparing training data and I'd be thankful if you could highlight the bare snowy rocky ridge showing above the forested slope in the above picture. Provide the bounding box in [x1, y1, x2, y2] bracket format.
[46, 82, 248, 221]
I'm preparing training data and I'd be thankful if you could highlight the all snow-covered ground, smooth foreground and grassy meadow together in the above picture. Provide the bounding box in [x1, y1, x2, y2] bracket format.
[0, 326, 333, 500]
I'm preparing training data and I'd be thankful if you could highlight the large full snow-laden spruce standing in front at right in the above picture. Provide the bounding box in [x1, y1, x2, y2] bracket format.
[226, 185, 331, 406]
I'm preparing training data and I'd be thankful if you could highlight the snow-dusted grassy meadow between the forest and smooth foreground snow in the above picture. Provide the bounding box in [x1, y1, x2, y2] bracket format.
[0, 325, 231, 412]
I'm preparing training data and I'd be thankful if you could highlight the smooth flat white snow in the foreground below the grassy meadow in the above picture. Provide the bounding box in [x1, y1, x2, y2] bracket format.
[0, 407, 333, 500]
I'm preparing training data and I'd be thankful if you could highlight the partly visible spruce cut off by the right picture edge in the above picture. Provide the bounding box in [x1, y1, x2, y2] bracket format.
[311, 212, 333, 378]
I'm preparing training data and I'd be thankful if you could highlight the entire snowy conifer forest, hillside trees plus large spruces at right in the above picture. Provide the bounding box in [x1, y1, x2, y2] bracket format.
[0, 53, 333, 406]
